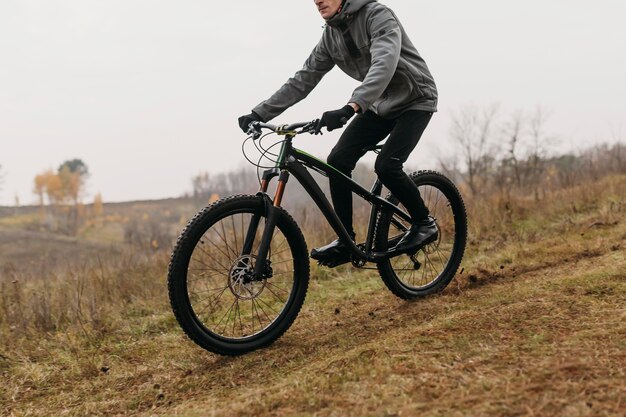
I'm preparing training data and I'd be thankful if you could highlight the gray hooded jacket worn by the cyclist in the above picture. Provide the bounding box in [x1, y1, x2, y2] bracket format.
[253, 0, 437, 121]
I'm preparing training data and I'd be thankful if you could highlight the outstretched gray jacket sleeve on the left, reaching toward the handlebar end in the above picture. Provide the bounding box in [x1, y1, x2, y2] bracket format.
[252, 39, 335, 122]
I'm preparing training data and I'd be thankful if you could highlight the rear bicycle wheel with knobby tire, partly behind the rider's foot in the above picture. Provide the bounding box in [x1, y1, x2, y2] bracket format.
[375, 171, 467, 299]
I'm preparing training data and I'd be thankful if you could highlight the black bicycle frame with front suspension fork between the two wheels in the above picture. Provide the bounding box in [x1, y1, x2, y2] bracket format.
[249, 134, 411, 276]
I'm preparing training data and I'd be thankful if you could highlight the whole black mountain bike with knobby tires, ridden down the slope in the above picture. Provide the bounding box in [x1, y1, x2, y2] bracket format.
[168, 120, 467, 355]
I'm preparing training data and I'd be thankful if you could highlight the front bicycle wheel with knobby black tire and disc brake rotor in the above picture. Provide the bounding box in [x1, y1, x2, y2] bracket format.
[168, 196, 309, 355]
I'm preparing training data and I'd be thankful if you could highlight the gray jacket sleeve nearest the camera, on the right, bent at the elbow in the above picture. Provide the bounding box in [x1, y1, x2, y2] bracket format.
[350, 7, 402, 112]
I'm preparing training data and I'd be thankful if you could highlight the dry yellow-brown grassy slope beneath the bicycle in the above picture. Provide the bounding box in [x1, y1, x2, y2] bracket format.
[0, 176, 626, 417]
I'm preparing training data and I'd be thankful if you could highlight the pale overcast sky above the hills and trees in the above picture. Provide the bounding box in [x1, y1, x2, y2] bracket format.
[0, 0, 626, 205]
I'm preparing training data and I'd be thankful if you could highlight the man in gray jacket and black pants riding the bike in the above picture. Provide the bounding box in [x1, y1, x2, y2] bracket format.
[239, 0, 438, 266]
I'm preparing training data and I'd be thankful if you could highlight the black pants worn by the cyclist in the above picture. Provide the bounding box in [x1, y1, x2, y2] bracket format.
[328, 110, 432, 235]
